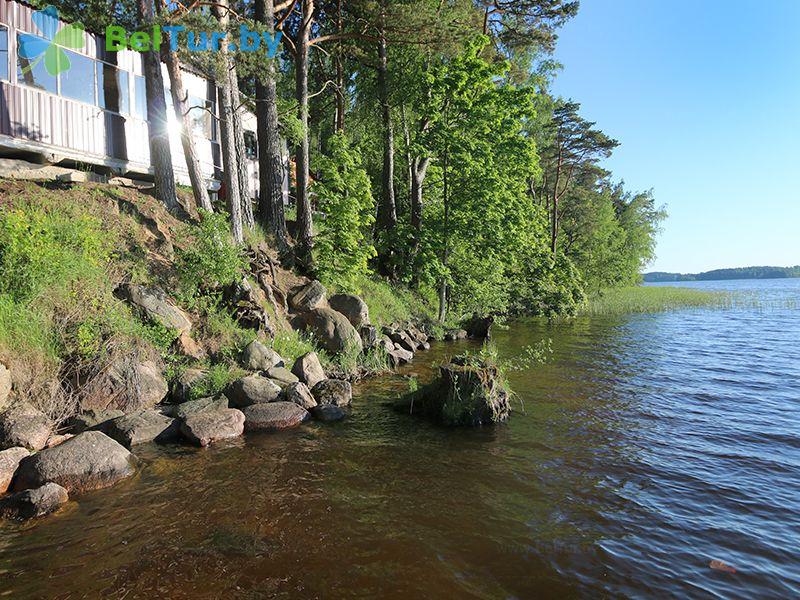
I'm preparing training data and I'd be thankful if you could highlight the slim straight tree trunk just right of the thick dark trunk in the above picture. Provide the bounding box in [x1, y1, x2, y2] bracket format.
[295, 0, 314, 268]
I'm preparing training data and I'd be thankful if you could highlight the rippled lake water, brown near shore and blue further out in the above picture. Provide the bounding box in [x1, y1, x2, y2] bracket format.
[0, 280, 800, 599]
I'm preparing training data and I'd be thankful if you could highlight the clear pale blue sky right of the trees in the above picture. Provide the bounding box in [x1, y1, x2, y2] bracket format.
[554, 0, 800, 273]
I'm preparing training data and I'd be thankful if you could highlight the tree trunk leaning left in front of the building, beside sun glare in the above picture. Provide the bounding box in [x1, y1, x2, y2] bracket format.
[156, 0, 214, 212]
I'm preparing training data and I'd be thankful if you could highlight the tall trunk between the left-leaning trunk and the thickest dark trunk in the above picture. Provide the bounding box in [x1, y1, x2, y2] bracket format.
[212, 0, 244, 244]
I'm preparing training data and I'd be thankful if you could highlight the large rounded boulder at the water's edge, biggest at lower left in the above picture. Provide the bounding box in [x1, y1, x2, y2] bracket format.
[12, 431, 134, 493]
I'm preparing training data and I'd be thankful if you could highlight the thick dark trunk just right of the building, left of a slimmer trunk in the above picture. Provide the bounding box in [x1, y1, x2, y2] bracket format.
[256, 0, 289, 252]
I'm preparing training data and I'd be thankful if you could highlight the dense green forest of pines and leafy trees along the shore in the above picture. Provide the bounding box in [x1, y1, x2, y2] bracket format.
[43, 0, 666, 322]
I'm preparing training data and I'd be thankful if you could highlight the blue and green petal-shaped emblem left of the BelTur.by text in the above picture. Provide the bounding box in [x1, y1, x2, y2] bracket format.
[18, 6, 84, 76]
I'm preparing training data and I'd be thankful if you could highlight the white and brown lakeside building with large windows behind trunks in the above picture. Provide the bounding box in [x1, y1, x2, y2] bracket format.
[0, 0, 288, 198]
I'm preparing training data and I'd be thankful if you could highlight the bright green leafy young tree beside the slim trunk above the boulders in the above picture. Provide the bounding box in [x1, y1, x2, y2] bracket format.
[313, 134, 375, 291]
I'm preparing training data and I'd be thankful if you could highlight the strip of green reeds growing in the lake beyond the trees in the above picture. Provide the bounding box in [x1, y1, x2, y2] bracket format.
[581, 286, 733, 316]
